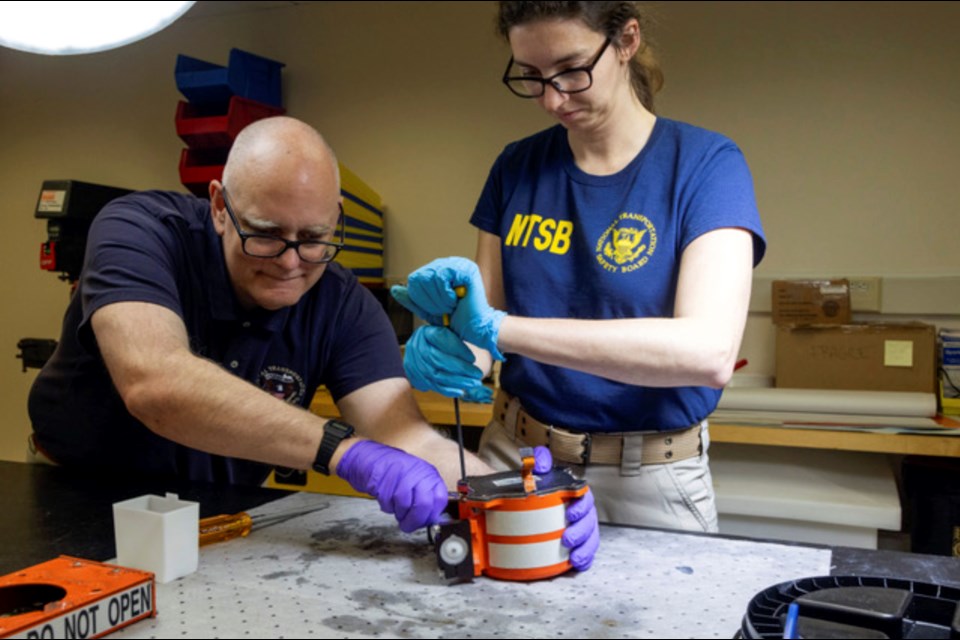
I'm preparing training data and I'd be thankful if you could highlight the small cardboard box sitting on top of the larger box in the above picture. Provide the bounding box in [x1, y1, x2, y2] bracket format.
[772, 279, 851, 325]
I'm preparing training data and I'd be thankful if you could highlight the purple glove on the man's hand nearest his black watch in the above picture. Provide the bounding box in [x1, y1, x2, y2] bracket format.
[337, 440, 449, 533]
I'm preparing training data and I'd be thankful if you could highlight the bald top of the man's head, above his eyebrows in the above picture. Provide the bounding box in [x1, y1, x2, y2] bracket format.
[223, 116, 340, 204]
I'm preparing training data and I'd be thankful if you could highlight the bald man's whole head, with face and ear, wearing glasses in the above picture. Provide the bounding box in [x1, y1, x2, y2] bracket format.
[209, 117, 343, 311]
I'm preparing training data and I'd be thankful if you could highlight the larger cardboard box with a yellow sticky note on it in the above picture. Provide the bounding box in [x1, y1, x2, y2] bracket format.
[776, 322, 937, 393]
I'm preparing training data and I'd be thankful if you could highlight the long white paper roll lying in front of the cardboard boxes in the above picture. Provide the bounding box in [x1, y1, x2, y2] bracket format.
[717, 388, 937, 417]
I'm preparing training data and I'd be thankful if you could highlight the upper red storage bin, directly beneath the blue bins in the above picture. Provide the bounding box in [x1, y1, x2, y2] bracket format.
[176, 96, 286, 149]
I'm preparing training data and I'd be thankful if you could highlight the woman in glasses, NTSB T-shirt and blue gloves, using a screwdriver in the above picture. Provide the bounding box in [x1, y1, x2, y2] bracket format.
[396, 2, 765, 544]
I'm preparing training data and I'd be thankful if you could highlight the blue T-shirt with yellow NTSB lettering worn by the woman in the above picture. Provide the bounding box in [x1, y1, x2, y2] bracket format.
[470, 118, 766, 432]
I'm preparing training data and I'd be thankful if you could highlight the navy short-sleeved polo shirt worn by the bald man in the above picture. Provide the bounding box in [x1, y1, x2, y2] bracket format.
[28, 191, 404, 484]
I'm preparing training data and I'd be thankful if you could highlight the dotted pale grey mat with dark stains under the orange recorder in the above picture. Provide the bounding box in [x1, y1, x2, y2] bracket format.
[112, 493, 830, 638]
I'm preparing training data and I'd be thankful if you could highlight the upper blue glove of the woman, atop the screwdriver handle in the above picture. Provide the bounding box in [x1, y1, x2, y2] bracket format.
[390, 257, 507, 360]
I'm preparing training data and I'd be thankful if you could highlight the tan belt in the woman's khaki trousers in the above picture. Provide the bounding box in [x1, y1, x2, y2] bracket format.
[493, 390, 701, 464]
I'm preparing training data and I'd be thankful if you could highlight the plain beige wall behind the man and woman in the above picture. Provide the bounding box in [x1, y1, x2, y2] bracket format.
[0, 2, 960, 460]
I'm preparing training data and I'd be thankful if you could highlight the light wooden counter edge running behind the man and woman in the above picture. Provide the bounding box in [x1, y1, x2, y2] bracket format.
[310, 389, 960, 458]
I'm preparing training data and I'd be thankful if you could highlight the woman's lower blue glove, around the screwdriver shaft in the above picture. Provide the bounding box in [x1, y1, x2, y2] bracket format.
[403, 326, 493, 402]
